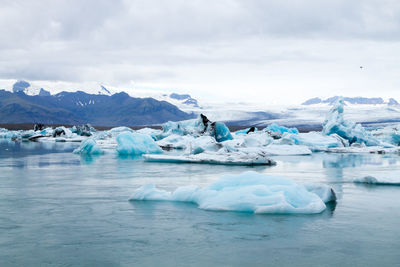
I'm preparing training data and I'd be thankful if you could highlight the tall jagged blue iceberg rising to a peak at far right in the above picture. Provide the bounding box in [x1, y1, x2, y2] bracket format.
[322, 98, 380, 146]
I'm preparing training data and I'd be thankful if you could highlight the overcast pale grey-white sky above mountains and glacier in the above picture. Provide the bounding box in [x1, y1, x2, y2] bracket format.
[0, 0, 400, 104]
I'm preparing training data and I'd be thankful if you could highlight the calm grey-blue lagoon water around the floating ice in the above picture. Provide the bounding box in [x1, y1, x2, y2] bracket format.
[0, 141, 400, 266]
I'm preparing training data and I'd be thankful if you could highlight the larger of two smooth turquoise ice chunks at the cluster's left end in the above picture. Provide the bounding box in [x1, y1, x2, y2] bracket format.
[117, 132, 162, 155]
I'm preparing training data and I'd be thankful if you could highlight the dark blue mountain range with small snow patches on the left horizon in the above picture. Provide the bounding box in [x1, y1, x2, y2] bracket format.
[0, 85, 194, 126]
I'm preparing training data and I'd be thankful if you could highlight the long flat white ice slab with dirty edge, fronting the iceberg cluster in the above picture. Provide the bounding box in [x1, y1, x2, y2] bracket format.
[143, 152, 276, 166]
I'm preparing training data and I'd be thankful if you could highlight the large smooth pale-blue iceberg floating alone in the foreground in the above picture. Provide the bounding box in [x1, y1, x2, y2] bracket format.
[131, 172, 332, 214]
